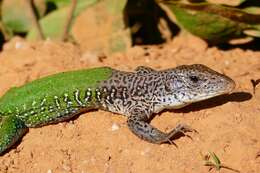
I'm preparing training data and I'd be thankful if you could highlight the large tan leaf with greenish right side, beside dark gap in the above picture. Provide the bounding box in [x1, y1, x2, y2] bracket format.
[72, 0, 131, 54]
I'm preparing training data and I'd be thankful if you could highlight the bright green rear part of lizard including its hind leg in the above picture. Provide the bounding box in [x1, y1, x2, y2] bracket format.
[0, 67, 112, 153]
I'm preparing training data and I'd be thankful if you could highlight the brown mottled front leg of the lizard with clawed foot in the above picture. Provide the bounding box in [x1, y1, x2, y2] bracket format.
[127, 107, 194, 144]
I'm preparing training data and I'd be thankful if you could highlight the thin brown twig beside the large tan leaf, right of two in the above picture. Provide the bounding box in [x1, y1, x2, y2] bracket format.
[61, 0, 77, 41]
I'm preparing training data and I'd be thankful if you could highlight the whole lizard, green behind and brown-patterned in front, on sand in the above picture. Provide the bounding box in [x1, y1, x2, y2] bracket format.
[0, 64, 235, 154]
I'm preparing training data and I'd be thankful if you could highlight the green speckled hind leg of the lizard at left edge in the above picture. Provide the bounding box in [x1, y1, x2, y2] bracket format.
[0, 116, 28, 155]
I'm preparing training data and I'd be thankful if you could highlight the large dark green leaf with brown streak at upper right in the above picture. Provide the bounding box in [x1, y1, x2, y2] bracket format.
[165, 1, 260, 43]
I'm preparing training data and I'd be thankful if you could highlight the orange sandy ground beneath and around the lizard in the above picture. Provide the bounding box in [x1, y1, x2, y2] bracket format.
[0, 11, 260, 173]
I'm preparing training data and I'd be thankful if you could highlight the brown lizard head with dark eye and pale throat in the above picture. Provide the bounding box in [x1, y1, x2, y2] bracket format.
[165, 64, 235, 107]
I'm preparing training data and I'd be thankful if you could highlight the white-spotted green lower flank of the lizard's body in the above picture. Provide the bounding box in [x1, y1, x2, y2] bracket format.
[16, 88, 96, 127]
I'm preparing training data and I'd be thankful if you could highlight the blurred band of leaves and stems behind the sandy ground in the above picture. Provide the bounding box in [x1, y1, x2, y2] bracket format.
[0, 0, 260, 52]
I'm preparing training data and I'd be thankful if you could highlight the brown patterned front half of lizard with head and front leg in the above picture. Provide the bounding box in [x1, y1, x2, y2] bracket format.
[95, 64, 235, 143]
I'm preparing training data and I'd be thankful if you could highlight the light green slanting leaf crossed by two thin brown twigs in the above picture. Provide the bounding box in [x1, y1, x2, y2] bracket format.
[26, 0, 98, 40]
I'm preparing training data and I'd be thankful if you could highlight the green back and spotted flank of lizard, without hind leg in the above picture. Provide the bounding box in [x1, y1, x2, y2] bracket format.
[0, 67, 112, 127]
